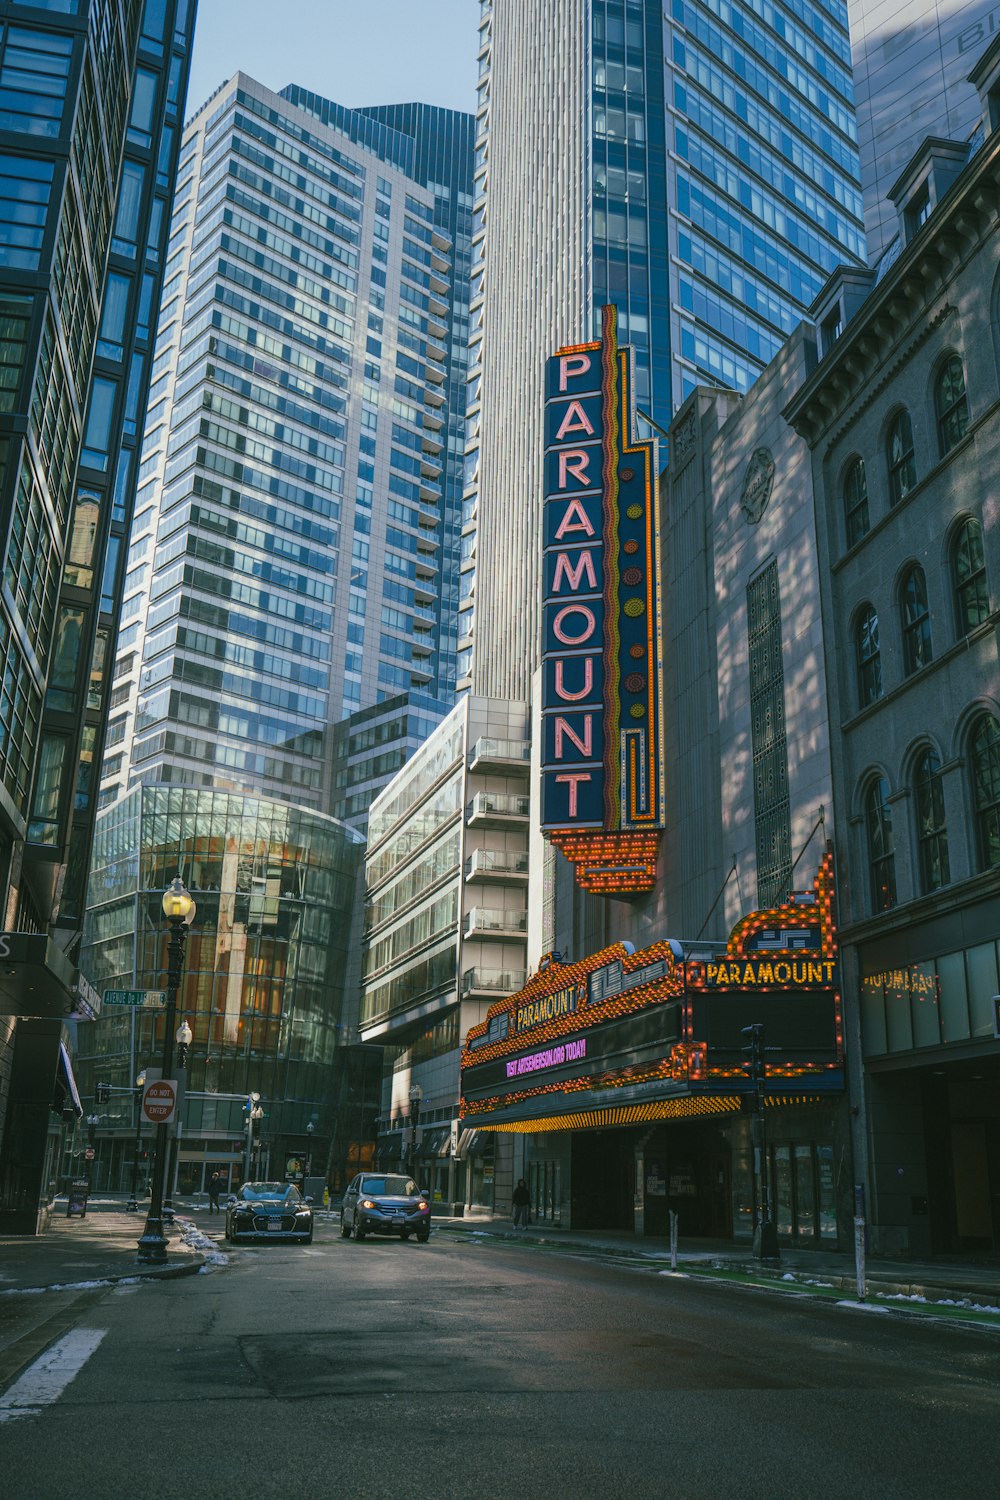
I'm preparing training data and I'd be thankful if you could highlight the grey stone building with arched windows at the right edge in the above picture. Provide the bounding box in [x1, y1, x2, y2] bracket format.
[786, 44, 1000, 1254]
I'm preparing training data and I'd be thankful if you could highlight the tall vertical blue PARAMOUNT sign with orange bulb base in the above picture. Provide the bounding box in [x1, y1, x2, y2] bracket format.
[541, 308, 664, 896]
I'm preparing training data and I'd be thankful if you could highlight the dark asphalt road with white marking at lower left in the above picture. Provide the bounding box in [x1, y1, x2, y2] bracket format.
[0, 1226, 1000, 1500]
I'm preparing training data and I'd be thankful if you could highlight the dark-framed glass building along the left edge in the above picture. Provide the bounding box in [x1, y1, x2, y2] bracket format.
[0, 0, 195, 1230]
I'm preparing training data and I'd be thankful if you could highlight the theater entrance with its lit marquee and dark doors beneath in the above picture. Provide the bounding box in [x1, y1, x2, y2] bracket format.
[460, 852, 852, 1247]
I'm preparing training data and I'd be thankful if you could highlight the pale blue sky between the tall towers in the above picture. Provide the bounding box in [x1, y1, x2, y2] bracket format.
[187, 0, 480, 114]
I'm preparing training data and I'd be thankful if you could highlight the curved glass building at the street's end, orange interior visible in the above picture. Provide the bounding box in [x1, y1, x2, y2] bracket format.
[78, 786, 364, 1191]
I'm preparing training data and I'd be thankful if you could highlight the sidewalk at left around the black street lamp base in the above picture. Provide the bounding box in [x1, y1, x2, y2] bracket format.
[0, 1197, 205, 1295]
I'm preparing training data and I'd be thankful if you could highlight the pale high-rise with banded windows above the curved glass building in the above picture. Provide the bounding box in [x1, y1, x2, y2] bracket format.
[102, 75, 465, 807]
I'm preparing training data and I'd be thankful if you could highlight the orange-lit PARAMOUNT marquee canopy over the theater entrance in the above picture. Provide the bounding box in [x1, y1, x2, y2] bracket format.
[462, 854, 844, 1131]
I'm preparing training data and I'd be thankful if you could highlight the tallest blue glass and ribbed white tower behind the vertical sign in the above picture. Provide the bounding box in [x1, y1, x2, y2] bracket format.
[459, 0, 865, 698]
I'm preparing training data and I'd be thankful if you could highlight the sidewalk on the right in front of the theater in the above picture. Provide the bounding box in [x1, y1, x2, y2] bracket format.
[433, 1217, 1000, 1311]
